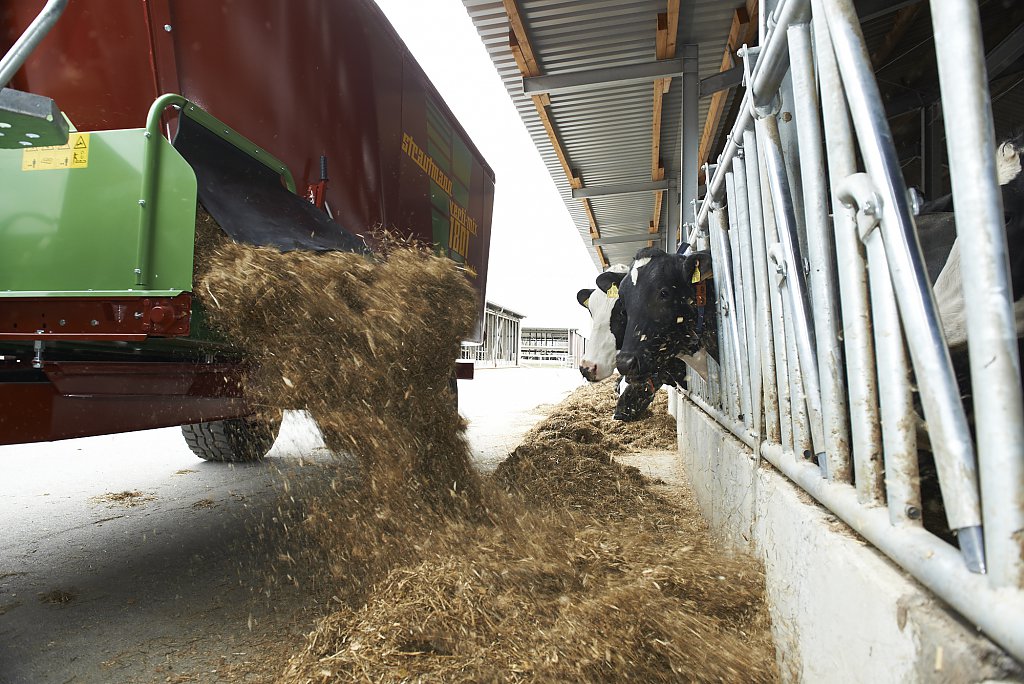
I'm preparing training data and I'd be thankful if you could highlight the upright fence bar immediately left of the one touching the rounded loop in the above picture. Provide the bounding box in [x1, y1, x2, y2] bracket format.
[787, 24, 850, 482]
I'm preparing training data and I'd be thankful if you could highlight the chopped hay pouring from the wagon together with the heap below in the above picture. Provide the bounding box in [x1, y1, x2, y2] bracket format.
[197, 210, 778, 684]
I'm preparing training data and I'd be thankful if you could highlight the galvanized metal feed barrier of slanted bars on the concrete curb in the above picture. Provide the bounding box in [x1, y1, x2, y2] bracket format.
[683, 0, 1024, 659]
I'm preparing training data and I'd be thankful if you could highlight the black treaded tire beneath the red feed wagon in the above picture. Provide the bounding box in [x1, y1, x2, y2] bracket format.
[181, 416, 281, 463]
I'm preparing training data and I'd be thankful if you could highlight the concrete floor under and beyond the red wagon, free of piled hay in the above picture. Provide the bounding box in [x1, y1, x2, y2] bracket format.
[0, 369, 582, 684]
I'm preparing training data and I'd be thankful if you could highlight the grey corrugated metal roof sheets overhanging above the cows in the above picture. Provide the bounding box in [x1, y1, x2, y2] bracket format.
[463, 0, 745, 266]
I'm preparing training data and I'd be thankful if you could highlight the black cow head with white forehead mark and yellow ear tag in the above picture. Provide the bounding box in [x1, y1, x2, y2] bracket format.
[612, 248, 718, 382]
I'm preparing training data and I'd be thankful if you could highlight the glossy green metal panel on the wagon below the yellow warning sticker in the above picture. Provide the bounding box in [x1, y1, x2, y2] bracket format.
[0, 129, 196, 297]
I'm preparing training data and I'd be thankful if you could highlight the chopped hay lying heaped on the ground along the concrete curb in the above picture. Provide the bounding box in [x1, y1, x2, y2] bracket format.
[281, 382, 777, 684]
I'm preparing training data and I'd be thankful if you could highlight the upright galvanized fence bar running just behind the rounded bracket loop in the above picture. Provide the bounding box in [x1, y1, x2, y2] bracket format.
[812, 0, 884, 504]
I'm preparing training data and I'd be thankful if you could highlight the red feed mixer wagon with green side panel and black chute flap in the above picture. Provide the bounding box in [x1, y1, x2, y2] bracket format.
[0, 0, 495, 461]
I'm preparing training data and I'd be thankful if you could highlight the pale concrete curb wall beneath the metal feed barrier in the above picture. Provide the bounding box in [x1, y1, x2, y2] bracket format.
[673, 392, 1024, 683]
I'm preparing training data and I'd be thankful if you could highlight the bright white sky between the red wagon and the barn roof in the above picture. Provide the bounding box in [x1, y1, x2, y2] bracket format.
[376, 0, 598, 335]
